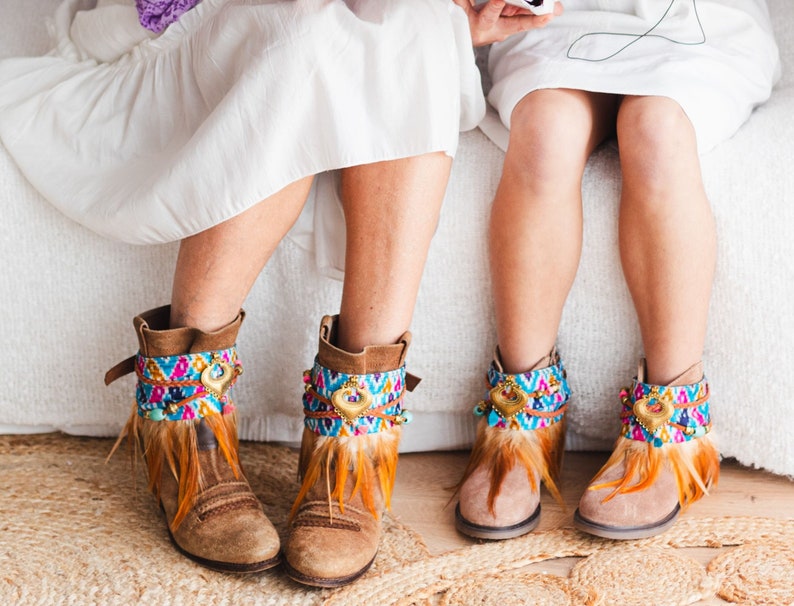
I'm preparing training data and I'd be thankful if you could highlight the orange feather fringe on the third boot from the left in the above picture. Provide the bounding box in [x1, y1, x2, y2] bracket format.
[456, 418, 565, 515]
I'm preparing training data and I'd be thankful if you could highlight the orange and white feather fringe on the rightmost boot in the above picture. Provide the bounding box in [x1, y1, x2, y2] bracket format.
[590, 436, 720, 509]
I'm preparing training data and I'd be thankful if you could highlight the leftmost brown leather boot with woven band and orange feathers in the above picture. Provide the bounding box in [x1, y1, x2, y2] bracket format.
[105, 306, 279, 573]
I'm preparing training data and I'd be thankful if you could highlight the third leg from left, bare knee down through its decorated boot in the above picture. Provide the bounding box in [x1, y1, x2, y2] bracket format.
[456, 90, 616, 539]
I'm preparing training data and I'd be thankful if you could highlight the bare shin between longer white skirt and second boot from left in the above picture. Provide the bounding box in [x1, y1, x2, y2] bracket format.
[337, 153, 452, 352]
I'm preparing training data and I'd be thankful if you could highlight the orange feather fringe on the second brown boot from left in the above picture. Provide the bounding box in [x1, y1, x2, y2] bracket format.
[289, 425, 402, 520]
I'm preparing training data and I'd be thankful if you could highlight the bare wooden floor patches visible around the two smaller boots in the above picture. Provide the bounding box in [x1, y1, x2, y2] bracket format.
[392, 452, 794, 604]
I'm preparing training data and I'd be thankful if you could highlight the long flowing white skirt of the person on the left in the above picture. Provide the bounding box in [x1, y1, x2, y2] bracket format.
[0, 0, 485, 244]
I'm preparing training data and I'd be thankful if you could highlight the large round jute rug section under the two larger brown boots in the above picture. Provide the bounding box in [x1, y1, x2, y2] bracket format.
[0, 435, 428, 606]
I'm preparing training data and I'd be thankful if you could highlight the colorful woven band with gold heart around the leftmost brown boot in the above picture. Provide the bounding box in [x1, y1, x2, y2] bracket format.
[135, 347, 243, 421]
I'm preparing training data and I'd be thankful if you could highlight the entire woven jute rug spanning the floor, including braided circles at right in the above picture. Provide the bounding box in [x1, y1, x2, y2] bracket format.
[0, 434, 794, 606]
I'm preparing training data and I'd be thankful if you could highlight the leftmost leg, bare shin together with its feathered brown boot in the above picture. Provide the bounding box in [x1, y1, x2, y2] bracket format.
[110, 178, 311, 572]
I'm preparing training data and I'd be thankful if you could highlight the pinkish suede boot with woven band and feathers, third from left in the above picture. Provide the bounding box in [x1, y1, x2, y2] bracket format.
[455, 352, 571, 539]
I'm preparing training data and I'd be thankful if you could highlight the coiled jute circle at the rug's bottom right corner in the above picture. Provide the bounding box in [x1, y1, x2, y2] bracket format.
[708, 540, 794, 606]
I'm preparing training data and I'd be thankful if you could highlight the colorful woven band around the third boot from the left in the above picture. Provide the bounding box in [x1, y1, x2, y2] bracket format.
[474, 357, 571, 429]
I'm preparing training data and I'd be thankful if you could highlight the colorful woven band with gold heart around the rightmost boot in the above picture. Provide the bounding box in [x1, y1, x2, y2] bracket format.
[620, 378, 711, 447]
